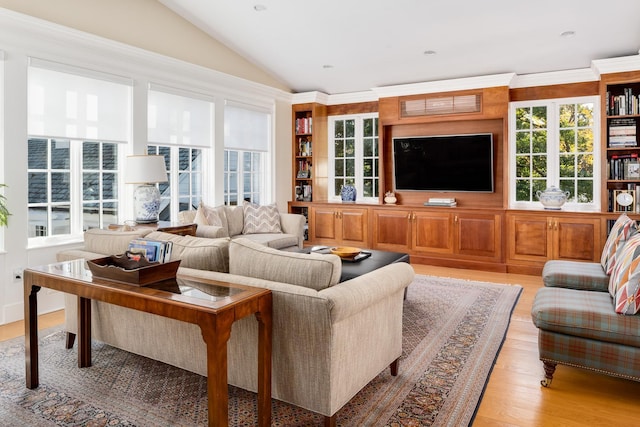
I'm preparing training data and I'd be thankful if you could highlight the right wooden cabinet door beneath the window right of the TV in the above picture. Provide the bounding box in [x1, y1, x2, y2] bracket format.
[551, 218, 601, 262]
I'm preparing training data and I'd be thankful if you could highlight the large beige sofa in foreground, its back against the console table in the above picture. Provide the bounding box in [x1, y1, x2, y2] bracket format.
[58, 227, 414, 425]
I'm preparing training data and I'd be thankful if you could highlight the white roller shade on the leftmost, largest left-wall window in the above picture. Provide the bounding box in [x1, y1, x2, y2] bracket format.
[28, 61, 131, 142]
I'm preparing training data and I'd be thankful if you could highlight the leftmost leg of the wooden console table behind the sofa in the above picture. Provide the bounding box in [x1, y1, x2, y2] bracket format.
[24, 272, 40, 389]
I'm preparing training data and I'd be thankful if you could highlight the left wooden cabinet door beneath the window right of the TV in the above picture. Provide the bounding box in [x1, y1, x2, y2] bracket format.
[507, 215, 553, 263]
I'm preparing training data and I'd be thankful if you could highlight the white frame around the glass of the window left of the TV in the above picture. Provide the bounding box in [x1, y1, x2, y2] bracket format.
[328, 113, 380, 203]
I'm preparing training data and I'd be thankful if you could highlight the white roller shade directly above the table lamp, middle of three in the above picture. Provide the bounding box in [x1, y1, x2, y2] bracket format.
[147, 90, 214, 147]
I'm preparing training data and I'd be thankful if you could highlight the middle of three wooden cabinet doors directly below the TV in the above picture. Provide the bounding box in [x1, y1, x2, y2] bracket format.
[411, 212, 453, 254]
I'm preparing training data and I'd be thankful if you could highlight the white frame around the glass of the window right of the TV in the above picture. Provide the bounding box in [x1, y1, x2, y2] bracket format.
[508, 95, 602, 212]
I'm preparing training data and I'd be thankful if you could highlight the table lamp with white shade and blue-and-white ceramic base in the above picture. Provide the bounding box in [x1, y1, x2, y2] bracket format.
[125, 155, 168, 224]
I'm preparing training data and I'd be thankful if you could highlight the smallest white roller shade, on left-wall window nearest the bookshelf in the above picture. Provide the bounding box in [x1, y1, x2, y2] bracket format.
[224, 104, 271, 151]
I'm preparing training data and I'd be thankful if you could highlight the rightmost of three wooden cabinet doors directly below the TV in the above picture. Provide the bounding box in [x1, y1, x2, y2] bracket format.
[454, 212, 502, 260]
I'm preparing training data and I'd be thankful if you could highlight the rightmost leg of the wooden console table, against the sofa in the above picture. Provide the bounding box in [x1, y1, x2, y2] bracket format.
[256, 294, 272, 427]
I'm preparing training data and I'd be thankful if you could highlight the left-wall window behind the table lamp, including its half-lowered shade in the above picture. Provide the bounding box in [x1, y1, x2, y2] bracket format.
[147, 86, 214, 221]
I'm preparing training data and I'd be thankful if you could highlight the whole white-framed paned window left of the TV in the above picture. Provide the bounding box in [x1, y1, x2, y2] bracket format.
[329, 114, 379, 201]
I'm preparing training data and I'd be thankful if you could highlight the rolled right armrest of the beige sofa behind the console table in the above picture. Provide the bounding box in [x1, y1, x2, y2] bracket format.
[318, 262, 415, 323]
